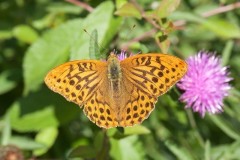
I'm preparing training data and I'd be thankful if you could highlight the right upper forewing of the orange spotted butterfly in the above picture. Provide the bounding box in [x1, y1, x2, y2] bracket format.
[121, 54, 187, 97]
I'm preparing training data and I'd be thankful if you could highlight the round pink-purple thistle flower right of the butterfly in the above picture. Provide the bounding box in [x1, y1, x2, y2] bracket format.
[177, 51, 232, 117]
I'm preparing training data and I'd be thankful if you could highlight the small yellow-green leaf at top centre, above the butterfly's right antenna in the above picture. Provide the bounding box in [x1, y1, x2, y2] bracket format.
[114, 3, 142, 19]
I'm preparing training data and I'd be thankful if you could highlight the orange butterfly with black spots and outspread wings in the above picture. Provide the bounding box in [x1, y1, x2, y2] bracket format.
[45, 52, 187, 128]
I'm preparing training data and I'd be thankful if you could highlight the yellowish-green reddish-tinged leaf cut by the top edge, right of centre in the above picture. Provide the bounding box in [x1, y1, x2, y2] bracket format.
[155, 0, 180, 19]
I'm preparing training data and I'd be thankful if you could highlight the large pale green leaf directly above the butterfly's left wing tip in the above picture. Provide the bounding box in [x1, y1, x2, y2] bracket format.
[23, 19, 82, 93]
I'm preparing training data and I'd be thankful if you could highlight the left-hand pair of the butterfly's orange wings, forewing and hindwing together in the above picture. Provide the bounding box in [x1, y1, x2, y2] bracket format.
[45, 60, 117, 128]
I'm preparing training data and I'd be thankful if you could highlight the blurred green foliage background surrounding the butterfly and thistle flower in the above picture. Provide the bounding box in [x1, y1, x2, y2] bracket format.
[0, 0, 240, 160]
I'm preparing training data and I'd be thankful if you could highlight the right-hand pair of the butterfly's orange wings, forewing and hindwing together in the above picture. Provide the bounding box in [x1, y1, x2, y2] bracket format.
[121, 54, 187, 126]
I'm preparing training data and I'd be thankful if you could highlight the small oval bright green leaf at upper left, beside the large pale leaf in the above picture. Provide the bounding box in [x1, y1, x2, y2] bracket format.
[13, 25, 38, 43]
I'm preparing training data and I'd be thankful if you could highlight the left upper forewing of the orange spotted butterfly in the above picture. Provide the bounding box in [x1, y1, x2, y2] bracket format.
[45, 60, 107, 106]
